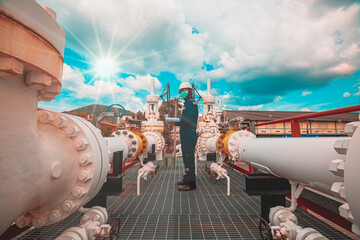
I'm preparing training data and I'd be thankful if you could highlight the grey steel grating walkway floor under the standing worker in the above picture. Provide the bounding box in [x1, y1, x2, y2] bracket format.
[19, 160, 351, 240]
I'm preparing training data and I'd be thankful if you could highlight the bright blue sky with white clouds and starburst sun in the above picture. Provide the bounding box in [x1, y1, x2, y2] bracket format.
[37, 0, 360, 111]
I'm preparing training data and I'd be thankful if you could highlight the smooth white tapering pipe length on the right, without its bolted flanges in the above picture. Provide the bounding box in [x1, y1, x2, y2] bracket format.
[239, 137, 349, 194]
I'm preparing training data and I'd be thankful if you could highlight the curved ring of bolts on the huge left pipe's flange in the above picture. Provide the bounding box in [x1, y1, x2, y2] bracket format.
[17, 110, 104, 227]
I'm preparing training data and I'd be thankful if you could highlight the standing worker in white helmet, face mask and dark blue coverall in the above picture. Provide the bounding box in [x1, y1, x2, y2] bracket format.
[175, 82, 198, 191]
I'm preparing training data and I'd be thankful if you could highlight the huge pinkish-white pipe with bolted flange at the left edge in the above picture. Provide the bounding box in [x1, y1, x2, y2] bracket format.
[0, 79, 109, 234]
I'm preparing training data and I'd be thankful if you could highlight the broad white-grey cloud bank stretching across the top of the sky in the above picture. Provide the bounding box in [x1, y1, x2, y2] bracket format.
[38, 0, 360, 106]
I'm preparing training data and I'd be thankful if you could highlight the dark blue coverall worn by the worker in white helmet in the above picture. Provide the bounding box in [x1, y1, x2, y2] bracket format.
[175, 98, 198, 189]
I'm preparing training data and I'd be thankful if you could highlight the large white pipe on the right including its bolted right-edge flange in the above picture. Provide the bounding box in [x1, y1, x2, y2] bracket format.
[238, 126, 360, 235]
